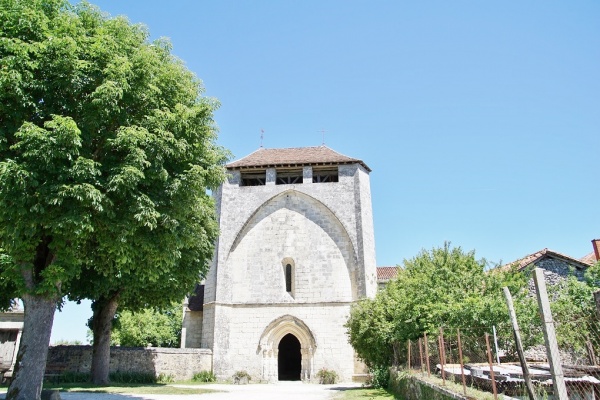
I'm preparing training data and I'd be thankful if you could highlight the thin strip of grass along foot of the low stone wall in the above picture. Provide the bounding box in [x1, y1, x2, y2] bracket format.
[44, 383, 217, 394]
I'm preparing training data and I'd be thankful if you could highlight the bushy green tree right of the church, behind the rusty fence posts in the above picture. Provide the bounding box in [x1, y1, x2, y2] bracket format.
[346, 243, 533, 368]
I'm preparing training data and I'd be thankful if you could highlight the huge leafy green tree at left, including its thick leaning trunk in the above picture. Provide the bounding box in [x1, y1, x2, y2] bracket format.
[0, 0, 227, 399]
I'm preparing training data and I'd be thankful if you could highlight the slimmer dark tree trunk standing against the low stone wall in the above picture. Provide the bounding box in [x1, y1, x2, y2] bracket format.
[92, 291, 120, 385]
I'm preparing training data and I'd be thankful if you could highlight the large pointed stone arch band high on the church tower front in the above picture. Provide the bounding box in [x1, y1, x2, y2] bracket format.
[226, 189, 359, 300]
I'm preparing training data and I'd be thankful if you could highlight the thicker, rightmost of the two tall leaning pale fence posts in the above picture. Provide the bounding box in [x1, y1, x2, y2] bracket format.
[533, 268, 569, 400]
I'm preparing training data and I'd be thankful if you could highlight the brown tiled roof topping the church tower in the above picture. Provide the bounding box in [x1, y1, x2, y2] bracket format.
[226, 146, 371, 172]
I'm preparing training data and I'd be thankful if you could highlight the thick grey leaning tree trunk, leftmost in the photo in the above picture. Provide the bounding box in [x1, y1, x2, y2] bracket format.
[6, 294, 56, 400]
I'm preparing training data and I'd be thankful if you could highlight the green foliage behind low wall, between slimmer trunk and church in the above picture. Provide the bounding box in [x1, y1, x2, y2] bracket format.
[112, 302, 182, 347]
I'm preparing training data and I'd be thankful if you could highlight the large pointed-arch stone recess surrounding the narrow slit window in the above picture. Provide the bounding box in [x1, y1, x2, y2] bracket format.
[226, 189, 358, 302]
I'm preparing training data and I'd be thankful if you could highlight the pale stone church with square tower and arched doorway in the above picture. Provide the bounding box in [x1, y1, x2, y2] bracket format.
[182, 146, 377, 382]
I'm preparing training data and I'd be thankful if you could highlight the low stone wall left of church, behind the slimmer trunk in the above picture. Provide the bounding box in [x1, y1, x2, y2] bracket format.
[47, 346, 212, 380]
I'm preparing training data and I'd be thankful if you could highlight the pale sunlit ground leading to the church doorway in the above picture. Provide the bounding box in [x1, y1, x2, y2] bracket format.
[0, 382, 360, 400]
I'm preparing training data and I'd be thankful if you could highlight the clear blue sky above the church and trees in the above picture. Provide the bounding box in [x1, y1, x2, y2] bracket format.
[52, 0, 600, 342]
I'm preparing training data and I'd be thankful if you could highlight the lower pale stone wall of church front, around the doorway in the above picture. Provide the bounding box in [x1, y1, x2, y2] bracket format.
[209, 303, 356, 382]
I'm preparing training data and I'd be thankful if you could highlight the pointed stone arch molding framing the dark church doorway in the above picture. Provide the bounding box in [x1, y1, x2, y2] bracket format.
[257, 315, 317, 382]
